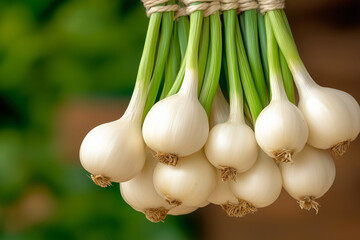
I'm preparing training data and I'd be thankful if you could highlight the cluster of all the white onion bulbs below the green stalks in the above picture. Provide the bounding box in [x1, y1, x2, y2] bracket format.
[80, 4, 360, 222]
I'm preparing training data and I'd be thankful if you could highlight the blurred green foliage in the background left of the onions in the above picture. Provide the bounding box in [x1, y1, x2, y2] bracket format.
[0, 0, 194, 240]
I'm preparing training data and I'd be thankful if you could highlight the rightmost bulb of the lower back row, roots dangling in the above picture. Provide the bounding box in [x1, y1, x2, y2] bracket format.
[280, 145, 336, 213]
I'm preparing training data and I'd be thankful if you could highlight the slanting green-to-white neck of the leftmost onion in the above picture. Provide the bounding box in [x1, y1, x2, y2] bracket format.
[123, 13, 162, 124]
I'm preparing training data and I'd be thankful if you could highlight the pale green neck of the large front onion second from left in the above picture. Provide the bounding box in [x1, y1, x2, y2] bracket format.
[179, 11, 203, 98]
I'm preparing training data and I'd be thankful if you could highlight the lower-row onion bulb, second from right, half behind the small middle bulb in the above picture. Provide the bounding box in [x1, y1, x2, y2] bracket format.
[230, 151, 282, 215]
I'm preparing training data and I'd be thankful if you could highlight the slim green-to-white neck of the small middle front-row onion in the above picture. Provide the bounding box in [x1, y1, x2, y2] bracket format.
[224, 9, 245, 123]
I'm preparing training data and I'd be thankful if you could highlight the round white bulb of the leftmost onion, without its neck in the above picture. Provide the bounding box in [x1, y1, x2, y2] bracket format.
[80, 118, 146, 182]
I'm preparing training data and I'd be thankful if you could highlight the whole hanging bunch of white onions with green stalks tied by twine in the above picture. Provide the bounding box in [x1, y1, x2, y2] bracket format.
[80, 0, 360, 222]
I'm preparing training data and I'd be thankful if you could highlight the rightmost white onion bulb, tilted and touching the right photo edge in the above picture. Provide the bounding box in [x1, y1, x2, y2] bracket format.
[293, 68, 360, 155]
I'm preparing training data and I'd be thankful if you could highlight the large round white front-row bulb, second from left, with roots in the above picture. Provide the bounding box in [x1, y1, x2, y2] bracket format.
[143, 70, 209, 165]
